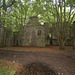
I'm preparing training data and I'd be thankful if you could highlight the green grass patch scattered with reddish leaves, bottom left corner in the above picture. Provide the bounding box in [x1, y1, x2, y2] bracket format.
[0, 60, 25, 75]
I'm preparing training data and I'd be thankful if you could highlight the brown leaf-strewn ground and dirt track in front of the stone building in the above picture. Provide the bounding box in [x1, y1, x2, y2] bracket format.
[0, 46, 75, 75]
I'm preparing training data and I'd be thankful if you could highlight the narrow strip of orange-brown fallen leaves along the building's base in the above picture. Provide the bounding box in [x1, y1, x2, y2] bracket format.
[0, 46, 72, 52]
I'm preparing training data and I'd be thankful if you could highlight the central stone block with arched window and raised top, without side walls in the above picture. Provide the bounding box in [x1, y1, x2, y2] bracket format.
[20, 17, 45, 47]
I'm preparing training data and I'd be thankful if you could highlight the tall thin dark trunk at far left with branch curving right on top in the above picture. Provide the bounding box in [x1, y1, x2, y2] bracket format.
[0, 0, 15, 45]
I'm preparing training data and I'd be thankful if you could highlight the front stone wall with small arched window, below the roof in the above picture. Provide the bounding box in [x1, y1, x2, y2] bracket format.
[22, 26, 45, 47]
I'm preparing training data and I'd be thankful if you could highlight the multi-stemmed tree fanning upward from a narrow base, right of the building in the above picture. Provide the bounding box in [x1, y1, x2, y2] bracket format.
[48, 0, 75, 49]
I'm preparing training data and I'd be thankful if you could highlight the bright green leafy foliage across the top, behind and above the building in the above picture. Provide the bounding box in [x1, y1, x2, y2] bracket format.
[0, 0, 75, 31]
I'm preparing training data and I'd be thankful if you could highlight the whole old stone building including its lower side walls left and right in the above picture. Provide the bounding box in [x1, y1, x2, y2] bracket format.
[0, 17, 72, 47]
